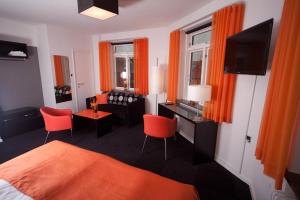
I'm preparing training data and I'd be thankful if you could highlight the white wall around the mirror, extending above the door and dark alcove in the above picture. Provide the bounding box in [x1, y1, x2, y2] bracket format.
[0, 18, 95, 110]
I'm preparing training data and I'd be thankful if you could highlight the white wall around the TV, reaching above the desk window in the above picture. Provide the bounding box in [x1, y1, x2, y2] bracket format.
[169, 0, 283, 200]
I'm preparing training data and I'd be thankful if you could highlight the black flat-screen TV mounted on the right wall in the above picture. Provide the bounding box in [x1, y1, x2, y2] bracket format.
[224, 19, 273, 75]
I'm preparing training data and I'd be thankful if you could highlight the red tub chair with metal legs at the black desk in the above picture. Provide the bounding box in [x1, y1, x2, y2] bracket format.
[142, 114, 177, 160]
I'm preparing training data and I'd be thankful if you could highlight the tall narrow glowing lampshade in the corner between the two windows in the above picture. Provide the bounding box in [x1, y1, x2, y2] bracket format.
[151, 66, 164, 94]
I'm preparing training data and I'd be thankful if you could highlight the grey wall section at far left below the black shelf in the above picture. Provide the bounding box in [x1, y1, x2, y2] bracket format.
[0, 47, 44, 111]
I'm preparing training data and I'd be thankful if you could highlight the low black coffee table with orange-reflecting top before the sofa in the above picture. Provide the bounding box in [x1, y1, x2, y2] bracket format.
[73, 109, 112, 138]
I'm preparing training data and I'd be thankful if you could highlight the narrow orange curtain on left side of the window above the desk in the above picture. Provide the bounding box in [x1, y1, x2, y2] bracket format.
[167, 30, 180, 103]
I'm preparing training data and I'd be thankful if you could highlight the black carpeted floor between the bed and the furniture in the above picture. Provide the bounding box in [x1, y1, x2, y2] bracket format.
[0, 124, 251, 200]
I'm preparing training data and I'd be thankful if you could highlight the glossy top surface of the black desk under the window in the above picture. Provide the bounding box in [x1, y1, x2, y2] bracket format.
[159, 103, 210, 123]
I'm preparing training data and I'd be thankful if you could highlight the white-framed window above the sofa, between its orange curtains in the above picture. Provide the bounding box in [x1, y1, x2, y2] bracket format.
[113, 44, 134, 89]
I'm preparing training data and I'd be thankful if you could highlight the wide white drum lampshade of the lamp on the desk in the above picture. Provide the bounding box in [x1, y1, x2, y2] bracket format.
[187, 85, 211, 103]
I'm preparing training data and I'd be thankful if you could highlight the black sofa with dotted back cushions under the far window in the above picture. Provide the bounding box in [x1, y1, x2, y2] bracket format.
[86, 91, 145, 127]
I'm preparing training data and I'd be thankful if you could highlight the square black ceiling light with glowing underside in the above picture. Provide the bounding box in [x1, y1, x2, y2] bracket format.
[77, 0, 119, 20]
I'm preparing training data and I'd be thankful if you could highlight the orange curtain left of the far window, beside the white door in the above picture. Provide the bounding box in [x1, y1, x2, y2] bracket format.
[99, 42, 112, 92]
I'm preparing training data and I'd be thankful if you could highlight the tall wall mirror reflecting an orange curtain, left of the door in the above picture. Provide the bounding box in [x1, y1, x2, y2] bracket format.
[53, 55, 72, 103]
